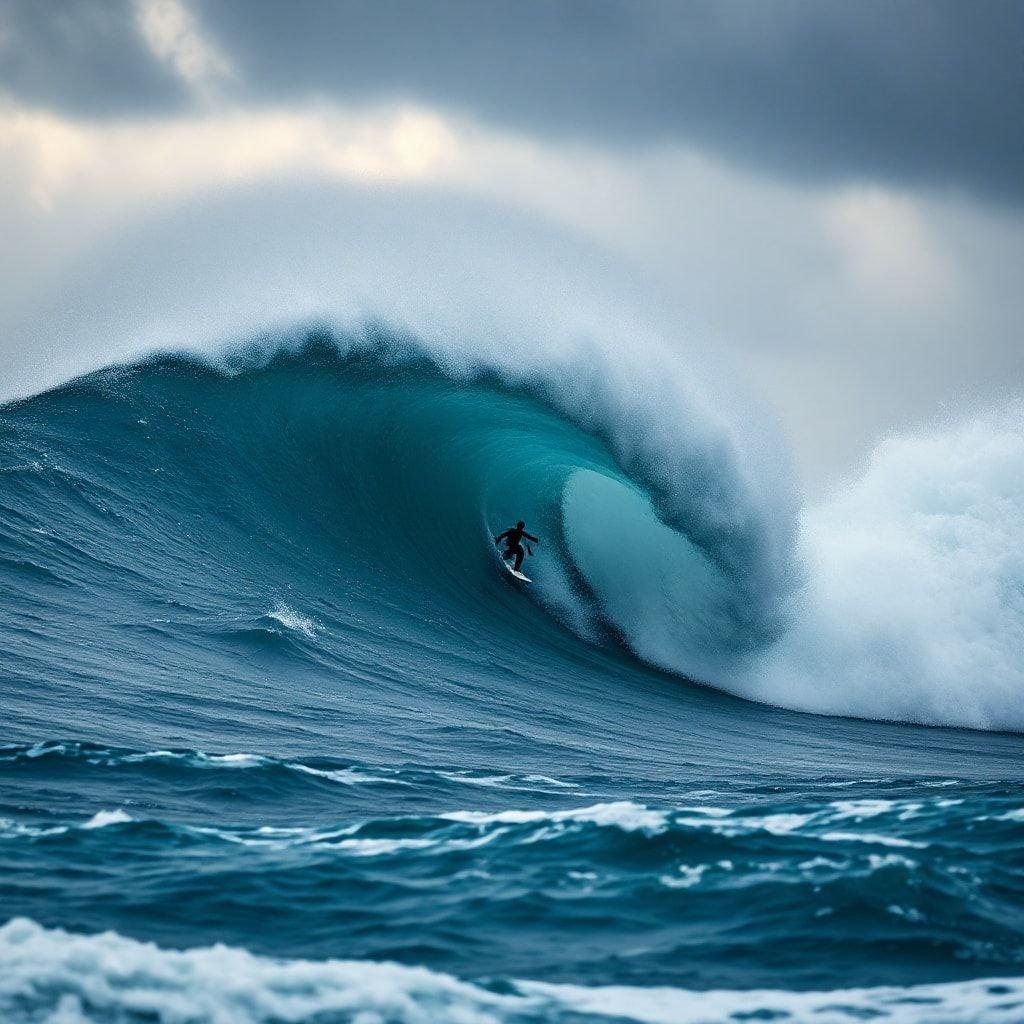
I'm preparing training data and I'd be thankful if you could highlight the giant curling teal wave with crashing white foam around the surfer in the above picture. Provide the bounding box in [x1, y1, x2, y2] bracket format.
[2, 327, 1024, 730]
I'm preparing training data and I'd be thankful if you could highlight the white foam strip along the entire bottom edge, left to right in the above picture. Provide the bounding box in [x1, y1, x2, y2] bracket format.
[0, 921, 1024, 1024]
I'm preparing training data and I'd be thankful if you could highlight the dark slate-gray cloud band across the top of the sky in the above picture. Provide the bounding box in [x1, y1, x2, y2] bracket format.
[0, 0, 1024, 202]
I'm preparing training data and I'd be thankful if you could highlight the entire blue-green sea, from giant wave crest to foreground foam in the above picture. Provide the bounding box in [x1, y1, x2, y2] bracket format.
[0, 330, 1024, 1024]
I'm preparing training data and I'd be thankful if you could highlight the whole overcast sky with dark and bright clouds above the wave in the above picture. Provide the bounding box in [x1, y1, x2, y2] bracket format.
[0, 0, 1024, 481]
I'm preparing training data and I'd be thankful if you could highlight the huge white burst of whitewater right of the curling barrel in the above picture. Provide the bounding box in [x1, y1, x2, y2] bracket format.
[727, 403, 1024, 733]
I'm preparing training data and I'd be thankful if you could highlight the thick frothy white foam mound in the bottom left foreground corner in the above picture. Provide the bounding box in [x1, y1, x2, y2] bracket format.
[0, 919, 528, 1024]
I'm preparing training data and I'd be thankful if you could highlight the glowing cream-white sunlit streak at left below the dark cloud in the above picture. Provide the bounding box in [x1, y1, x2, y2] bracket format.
[0, 106, 464, 211]
